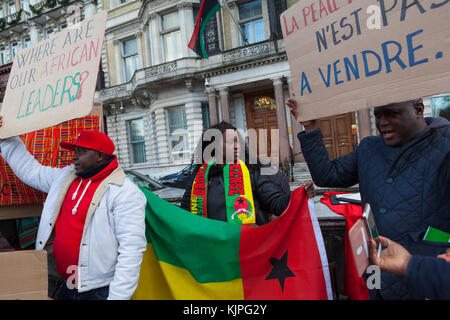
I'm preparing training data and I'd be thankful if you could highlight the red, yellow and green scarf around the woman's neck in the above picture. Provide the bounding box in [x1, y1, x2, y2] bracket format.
[191, 159, 256, 224]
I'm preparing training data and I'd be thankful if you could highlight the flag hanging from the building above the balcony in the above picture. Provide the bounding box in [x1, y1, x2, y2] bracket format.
[188, 0, 221, 59]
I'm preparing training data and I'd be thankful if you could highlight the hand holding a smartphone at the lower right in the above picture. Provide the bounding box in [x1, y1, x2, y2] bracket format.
[369, 236, 411, 277]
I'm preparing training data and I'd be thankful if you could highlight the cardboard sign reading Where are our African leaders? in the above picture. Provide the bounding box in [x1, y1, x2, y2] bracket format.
[0, 11, 107, 138]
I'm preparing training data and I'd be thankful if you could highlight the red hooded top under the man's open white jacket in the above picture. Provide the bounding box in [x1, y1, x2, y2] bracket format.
[53, 158, 118, 280]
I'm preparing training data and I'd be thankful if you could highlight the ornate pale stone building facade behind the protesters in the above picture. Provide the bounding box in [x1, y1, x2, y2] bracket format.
[0, 0, 446, 178]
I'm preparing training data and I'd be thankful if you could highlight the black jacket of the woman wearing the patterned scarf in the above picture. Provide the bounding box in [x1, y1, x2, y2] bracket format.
[181, 165, 291, 225]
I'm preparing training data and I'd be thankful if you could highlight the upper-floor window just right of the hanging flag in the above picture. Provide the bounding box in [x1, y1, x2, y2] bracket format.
[238, 0, 265, 45]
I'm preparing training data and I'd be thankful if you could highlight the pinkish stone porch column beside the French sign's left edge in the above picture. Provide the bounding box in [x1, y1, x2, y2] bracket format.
[272, 78, 290, 164]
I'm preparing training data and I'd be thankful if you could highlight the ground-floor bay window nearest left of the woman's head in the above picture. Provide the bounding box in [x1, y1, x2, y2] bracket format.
[166, 107, 190, 161]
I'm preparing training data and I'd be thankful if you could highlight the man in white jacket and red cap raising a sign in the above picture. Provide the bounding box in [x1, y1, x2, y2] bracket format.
[0, 116, 147, 300]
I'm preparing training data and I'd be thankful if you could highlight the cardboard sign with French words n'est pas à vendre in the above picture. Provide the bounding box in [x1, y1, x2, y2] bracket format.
[280, 0, 450, 121]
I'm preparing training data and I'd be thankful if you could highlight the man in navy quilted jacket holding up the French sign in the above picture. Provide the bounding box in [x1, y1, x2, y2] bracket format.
[287, 98, 450, 299]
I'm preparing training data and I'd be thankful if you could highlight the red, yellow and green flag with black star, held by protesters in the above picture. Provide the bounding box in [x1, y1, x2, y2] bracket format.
[133, 187, 332, 300]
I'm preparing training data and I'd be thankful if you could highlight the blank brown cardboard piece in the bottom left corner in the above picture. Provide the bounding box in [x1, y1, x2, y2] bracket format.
[0, 250, 48, 300]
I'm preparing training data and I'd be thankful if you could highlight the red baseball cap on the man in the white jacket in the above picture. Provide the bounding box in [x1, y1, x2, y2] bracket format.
[61, 131, 116, 156]
